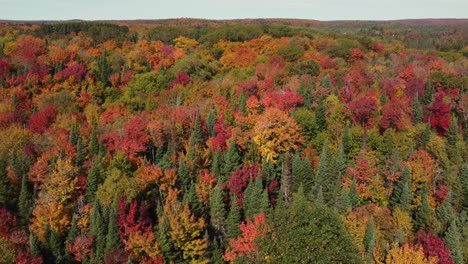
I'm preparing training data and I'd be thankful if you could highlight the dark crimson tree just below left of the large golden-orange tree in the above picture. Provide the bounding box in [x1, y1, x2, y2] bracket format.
[223, 164, 258, 208]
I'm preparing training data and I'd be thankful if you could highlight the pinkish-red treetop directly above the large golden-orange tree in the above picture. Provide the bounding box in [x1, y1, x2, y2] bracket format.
[260, 88, 303, 111]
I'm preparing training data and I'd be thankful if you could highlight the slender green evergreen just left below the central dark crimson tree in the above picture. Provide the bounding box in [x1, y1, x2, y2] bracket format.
[210, 184, 226, 237]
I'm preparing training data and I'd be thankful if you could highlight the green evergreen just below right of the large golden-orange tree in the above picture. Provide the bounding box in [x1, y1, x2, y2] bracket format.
[291, 152, 313, 192]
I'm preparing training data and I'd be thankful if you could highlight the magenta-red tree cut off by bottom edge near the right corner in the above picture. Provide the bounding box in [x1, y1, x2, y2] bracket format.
[418, 230, 455, 264]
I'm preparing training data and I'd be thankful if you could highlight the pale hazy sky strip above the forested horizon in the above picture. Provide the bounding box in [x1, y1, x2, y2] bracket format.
[0, 0, 468, 20]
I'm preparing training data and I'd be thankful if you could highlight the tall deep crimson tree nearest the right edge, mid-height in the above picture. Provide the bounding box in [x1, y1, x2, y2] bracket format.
[426, 90, 450, 135]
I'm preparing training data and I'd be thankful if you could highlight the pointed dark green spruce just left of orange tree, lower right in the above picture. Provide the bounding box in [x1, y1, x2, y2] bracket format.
[390, 166, 412, 213]
